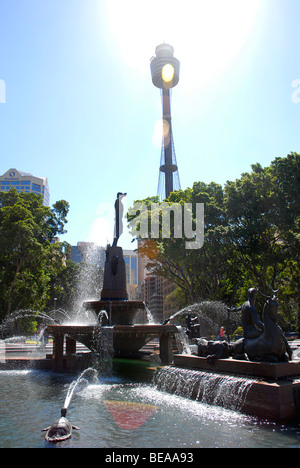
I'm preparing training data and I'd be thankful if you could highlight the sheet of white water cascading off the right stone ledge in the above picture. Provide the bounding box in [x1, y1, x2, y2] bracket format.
[153, 366, 255, 411]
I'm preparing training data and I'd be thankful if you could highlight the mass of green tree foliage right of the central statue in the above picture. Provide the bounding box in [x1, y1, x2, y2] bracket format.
[128, 153, 300, 326]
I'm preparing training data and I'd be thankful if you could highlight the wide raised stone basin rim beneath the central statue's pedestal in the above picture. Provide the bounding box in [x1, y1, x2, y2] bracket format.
[48, 324, 178, 357]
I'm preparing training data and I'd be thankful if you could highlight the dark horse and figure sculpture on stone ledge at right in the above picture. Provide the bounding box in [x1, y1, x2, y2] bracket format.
[161, 288, 300, 421]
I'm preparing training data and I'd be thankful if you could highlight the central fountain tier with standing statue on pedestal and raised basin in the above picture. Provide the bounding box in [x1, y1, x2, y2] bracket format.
[48, 192, 178, 371]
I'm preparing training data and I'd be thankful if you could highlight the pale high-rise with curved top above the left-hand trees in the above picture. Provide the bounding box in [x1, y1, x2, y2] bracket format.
[0, 169, 50, 206]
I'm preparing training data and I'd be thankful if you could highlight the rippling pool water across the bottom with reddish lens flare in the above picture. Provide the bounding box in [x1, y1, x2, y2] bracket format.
[0, 370, 300, 449]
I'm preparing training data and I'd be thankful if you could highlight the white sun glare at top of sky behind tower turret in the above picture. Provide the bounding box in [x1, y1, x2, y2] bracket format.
[106, 0, 262, 89]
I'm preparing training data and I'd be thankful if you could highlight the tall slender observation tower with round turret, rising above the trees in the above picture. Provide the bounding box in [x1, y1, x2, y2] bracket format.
[150, 43, 180, 200]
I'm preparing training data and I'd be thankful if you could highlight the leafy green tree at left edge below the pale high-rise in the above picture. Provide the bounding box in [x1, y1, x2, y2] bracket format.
[0, 189, 68, 317]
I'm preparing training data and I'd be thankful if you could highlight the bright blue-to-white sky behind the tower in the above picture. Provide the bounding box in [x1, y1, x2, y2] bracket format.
[0, 0, 300, 248]
